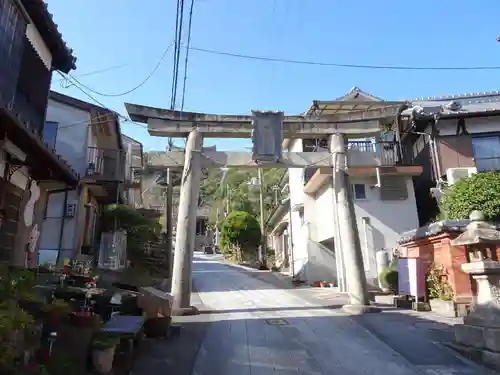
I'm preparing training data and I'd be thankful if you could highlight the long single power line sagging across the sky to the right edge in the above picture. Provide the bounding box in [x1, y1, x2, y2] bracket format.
[187, 46, 500, 71]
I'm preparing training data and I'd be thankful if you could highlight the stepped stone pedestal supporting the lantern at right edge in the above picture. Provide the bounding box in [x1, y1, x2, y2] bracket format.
[454, 260, 500, 370]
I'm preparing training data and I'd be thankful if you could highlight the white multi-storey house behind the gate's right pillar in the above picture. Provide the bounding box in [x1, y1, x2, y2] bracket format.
[270, 88, 422, 290]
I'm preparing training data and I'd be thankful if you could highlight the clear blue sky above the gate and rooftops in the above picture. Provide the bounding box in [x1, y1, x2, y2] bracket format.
[46, 0, 500, 151]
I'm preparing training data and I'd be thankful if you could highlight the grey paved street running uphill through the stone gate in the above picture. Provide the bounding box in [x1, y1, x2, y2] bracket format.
[134, 254, 490, 375]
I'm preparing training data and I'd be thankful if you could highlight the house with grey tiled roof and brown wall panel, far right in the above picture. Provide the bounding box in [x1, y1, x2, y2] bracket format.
[399, 91, 500, 225]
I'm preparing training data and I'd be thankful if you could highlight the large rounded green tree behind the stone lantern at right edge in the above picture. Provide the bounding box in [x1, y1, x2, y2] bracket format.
[440, 171, 500, 221]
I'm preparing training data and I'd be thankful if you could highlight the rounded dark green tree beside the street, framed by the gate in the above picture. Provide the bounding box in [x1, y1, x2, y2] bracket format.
[220, 211, 261, 252]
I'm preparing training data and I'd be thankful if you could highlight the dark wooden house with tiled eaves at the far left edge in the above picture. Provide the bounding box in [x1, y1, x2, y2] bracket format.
[0, 0, 78, 267]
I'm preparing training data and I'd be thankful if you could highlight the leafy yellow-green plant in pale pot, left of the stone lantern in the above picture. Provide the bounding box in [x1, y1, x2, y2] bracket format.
[426, 264, 457, 318]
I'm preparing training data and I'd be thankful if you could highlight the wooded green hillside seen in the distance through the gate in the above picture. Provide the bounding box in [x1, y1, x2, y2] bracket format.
[143, 151, 286, 223]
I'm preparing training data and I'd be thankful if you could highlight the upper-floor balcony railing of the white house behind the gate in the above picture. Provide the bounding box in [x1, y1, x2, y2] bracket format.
[304, 141, 415, 185]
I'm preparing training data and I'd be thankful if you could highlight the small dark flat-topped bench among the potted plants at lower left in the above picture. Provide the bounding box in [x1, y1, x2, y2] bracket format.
[100, 315, 146, 371]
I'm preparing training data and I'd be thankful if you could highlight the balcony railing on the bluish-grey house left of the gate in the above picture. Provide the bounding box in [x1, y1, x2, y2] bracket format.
[85, 147, 125, 181]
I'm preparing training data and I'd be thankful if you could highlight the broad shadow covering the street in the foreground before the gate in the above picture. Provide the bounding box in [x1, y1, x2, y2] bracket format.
[134, 308, 491, 375]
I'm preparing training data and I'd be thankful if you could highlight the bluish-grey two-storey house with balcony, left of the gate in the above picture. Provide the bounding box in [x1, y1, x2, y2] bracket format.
[39, 91, 129, 264]
